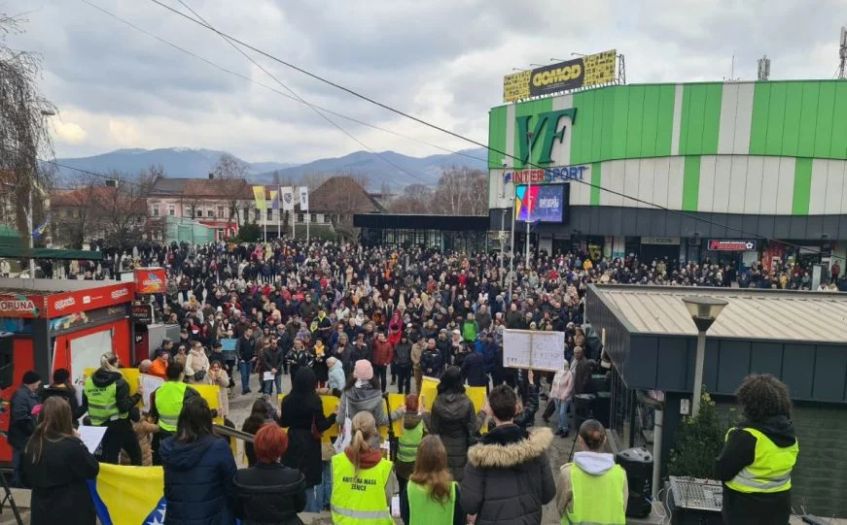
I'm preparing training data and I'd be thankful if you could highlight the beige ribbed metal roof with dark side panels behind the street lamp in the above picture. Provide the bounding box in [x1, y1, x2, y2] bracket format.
[585, 284, 847, 404]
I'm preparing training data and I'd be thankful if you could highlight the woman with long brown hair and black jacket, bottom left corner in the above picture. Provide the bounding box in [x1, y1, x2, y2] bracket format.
[22, 396, 100, 525]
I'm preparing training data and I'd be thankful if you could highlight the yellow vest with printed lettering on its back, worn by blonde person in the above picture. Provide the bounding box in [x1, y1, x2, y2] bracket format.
[330, 452, 394, 525]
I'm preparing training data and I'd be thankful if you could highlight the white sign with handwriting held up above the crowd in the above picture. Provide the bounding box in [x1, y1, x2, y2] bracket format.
[503, 330, 565, 372]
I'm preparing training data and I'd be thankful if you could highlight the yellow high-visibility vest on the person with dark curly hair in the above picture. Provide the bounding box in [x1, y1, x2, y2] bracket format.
[726, 427, 800, 493]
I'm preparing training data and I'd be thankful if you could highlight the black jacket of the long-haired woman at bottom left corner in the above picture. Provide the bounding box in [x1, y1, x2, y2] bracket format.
[22, 437, 100, 525]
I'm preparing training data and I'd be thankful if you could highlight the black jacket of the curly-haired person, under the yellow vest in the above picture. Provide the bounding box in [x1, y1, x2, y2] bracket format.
[715, 416, 797, 525]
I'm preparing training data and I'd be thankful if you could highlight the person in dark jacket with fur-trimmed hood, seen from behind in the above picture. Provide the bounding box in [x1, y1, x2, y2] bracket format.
[464, 385, 556, 525]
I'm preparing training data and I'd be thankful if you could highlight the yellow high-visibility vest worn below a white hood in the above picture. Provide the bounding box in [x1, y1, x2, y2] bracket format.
[562, 463, 626, 525]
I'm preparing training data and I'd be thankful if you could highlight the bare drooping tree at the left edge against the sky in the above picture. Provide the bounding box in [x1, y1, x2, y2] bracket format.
[0, 14, 55, 244]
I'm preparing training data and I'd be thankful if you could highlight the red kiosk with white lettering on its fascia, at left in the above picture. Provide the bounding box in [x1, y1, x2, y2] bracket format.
[0, 279, 135, 461]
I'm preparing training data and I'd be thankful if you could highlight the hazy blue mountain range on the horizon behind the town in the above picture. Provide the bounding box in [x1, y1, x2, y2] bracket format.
[51, 148, 486, 191]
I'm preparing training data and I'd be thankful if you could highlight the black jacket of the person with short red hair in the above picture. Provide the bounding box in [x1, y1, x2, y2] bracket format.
[233, 463, 306, 525]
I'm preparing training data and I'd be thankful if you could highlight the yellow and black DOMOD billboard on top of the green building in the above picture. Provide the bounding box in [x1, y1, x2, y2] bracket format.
[503, 49, 618, 102]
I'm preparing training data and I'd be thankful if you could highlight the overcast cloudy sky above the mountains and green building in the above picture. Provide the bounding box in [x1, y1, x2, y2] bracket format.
[9, 0, 847, 162]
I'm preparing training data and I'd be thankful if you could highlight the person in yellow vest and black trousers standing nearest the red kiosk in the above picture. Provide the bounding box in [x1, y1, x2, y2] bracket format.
[82, 354, 142, 465]
